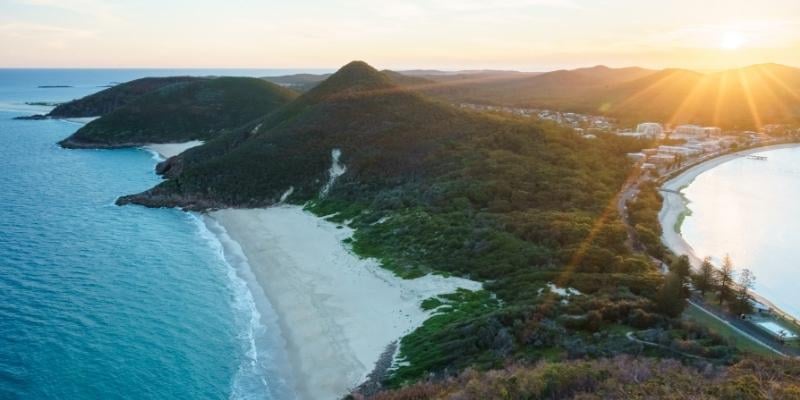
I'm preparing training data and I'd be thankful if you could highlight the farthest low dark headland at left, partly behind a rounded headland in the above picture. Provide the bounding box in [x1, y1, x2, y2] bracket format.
[47, 76, 205, 118]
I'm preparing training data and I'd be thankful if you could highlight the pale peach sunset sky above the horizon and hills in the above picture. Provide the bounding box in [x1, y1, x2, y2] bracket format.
[0, 0, 800, 71]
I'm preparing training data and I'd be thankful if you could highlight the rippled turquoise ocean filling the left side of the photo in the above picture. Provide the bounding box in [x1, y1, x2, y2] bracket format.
[0, 70, 324, 400]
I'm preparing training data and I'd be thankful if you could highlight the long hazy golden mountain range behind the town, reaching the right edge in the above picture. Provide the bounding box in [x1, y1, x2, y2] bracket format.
[412, 64, 800, 129]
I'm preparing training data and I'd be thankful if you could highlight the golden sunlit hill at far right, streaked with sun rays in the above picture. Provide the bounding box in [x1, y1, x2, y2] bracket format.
[596, 64, 800, 129]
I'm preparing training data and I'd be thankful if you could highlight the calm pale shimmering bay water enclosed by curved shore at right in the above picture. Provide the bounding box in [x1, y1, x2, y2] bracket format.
[681, 147, 800, 317]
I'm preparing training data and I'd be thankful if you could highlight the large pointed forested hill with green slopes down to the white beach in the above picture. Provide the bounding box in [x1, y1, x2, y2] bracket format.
[118, 62, 708, 384]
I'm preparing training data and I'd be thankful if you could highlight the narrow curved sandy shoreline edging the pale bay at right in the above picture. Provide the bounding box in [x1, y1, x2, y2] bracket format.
[658, 143, 800, 318]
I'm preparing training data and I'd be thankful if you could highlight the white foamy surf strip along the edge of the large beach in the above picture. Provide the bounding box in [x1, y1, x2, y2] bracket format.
[189, 213, 294, 400]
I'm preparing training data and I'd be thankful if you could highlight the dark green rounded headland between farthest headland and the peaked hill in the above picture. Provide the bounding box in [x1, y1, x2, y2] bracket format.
[61, 78, 296, 148]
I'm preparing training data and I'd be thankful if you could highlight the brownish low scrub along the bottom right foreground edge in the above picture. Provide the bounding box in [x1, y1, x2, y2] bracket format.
[352, 356, 800, 400]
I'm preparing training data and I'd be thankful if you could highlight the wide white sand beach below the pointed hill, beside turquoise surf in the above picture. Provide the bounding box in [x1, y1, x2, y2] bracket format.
[207, 206, 481, 400]
